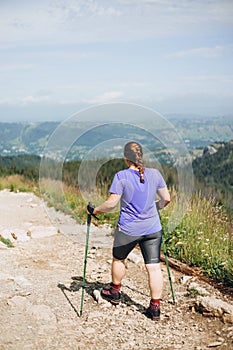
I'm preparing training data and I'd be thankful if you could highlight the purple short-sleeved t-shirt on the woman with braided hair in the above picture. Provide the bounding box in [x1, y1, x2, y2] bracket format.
[109, 168, 166, 236]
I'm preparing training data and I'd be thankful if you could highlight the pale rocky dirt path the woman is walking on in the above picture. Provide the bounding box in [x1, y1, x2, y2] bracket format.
[0, 190, 233, 350]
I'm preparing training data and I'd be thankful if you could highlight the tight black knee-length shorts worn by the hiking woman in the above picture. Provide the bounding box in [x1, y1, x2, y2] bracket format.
[113, 227, 162, 264]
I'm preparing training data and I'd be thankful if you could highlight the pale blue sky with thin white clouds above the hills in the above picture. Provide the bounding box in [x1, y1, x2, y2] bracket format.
[0, 0, 233, 121]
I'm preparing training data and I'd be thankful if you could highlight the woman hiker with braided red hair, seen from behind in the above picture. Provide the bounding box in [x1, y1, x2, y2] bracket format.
[87, 142, 170, 320]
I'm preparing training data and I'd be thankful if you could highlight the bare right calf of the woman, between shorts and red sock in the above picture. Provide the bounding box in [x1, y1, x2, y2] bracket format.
[145, 263, 163, 299]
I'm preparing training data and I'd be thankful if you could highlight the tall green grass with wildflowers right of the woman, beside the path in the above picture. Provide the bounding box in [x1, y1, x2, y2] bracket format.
[162, 195, 233, 285]
